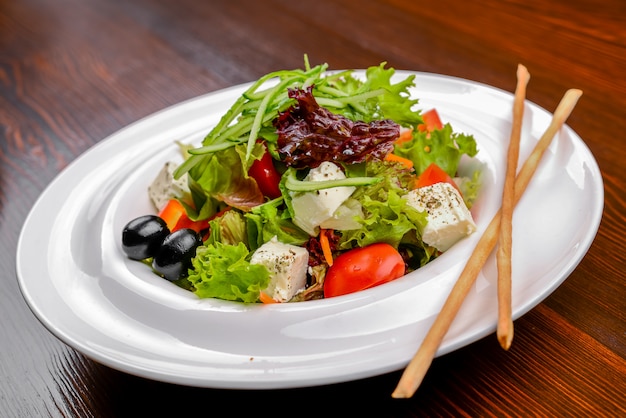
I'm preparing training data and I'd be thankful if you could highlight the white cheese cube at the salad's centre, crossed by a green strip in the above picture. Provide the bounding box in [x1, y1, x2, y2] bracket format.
[291, 161, 356, 236]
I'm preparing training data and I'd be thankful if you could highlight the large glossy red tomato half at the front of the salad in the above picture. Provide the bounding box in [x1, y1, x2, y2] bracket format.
[324, 243, 405, 298]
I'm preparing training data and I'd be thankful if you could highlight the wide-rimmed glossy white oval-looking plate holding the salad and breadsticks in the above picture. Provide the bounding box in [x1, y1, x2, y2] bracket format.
[16, 71, 603, 389]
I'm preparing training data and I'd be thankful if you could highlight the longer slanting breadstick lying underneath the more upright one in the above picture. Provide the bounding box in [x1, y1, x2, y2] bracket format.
[391, 89, 582, 398]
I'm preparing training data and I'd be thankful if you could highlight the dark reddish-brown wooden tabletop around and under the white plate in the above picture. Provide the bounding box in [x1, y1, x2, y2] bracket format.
[0, 0, 626, 417]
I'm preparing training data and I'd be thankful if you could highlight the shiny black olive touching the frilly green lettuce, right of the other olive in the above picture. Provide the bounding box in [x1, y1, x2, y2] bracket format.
[152, 229, 202, 281]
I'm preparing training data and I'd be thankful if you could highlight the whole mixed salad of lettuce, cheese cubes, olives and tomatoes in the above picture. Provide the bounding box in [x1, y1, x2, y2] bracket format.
[122, 56, 480, 303]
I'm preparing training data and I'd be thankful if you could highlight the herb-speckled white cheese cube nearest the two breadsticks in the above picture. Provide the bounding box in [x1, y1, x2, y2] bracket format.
[405, 183, 476, 251]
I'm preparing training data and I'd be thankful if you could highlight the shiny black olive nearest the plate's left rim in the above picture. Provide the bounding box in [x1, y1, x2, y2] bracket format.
[122, 215, 170, 260]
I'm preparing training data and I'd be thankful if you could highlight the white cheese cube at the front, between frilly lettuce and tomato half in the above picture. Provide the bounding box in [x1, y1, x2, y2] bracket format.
[250, 237, 309, 302]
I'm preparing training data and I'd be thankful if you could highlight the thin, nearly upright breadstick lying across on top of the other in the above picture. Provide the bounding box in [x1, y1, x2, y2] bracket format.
[496, 64, 530, 350]
